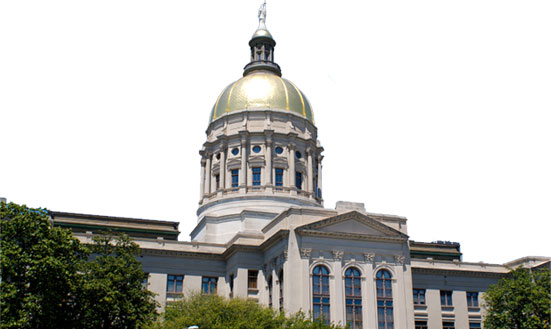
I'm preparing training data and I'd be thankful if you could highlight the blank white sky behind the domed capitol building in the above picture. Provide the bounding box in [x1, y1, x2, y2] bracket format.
[0, 0, 551, 263]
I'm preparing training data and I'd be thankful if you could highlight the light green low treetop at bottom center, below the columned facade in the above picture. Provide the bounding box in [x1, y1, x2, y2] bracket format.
[150, 294, 341, 329]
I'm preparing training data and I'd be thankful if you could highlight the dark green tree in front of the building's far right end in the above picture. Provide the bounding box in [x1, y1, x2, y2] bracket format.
[484, 267, 551, 329]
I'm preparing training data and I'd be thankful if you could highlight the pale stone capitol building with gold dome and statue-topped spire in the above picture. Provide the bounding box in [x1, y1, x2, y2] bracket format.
[51, 8, 550, 329]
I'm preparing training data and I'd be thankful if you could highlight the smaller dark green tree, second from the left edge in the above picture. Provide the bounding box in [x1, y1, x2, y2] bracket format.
[78, 235, 157, 329]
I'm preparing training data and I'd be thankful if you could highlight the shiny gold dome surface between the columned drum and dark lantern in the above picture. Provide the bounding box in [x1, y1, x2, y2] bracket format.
[210, 71, 314, 123]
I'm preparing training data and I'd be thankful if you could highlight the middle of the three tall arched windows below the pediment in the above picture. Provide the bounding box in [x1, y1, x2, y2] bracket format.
[344, 267, 362, 329]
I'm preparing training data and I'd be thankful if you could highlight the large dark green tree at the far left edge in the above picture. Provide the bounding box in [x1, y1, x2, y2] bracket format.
[0, 202, 88, 328]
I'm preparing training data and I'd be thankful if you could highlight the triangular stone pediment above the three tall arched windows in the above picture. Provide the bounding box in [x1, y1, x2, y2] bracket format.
[297, 211, 408, 240]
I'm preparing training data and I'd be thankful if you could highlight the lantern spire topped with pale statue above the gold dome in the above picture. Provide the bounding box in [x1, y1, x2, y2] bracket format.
[243, 0, 281, 76]
